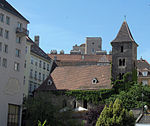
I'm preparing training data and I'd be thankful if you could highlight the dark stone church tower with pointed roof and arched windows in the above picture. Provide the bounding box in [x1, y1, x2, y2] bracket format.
[111, 21, 138, 80]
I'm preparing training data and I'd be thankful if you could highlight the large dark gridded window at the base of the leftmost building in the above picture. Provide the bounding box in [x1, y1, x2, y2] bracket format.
[7, 104, 20, 126]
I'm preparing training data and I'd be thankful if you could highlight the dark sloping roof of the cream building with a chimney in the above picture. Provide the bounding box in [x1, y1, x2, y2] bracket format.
[26, 37, 51, 61]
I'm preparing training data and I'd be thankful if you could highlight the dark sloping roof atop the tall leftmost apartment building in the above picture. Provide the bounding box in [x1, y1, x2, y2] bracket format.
[0, 0, 29, 23]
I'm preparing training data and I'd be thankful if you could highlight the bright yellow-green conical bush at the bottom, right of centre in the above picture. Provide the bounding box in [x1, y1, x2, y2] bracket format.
[96, 99, 135, 126]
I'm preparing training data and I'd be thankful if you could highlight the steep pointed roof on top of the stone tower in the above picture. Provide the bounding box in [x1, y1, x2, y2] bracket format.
[112, 21, 135, 42]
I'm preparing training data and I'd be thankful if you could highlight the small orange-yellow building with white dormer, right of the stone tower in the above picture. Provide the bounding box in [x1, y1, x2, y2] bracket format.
[137, 58, 150, 85]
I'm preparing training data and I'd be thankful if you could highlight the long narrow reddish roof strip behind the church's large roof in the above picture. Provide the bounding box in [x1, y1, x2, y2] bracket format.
[48, 54, 112, 62]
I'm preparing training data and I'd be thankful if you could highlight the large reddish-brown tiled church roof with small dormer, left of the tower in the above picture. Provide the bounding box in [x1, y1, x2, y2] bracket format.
[39, 65, 111, 90]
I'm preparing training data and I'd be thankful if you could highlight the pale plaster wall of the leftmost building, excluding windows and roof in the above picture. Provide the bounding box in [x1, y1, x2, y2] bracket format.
[0, 9, 27, 126]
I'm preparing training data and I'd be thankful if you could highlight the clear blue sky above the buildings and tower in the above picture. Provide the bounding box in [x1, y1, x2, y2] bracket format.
[7, 0, 150, 62]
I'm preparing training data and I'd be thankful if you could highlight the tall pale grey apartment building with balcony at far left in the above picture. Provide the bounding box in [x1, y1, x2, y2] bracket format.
[0, 0, 29, 126]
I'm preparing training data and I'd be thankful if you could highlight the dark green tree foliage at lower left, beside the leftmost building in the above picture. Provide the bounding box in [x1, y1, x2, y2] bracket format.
[25, 92, 79, 126]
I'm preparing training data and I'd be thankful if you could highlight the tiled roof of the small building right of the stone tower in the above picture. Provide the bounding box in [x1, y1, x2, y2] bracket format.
[137, 59, 150, 71]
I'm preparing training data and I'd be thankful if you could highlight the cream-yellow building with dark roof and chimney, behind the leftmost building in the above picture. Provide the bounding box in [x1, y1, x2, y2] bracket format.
[23, 36, 53, 97]
